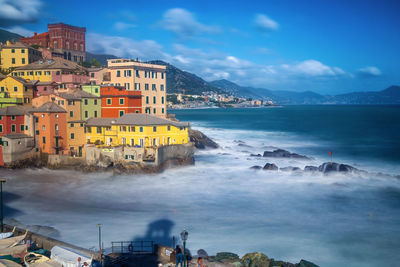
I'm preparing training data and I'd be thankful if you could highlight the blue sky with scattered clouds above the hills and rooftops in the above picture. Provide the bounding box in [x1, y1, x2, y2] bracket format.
[0, 0, 400, 94]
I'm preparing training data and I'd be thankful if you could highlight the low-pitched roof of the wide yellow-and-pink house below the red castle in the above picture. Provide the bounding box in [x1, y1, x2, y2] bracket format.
[15, 57, 86, 71]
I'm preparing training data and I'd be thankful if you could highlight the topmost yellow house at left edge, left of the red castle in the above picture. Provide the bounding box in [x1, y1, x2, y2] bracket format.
[0, 41, 42, 70]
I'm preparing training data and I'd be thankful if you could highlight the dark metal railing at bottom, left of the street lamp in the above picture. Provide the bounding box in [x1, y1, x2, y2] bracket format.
[111, 241, 154, 254]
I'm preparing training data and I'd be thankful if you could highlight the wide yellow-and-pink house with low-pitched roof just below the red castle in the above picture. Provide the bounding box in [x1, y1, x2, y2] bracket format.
[11, 58, 89, 88]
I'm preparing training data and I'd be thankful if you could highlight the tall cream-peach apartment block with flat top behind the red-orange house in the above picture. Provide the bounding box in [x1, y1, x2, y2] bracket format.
[107, 59, 167, 118]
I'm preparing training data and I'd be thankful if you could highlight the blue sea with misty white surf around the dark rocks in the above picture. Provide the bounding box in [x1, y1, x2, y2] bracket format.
[0, 105, 400, 267]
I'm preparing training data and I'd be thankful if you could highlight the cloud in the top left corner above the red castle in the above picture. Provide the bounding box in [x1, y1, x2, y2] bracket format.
[0, 0, 43, 27]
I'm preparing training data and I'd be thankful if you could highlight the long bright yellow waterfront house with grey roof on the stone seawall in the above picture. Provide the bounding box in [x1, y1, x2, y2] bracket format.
[85, 113, 189, 147]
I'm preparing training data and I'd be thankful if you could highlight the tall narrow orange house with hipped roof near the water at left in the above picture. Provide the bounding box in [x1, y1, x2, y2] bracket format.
[32, 102, 68, 154]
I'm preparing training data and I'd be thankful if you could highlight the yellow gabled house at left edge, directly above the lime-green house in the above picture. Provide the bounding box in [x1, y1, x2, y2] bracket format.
[0, 76, 37, 105]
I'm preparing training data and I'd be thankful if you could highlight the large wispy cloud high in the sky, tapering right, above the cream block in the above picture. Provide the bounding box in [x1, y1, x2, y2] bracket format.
[160, 8, 220, 38]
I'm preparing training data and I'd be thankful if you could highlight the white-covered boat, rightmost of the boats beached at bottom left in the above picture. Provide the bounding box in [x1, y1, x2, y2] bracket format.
[50, 246, 92, 267]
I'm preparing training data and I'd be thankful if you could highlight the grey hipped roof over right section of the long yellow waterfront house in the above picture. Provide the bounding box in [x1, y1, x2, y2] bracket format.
[114, 113, 189, 127]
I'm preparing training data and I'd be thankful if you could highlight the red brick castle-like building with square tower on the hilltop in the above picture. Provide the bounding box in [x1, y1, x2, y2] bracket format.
[20, 23, 86, 62]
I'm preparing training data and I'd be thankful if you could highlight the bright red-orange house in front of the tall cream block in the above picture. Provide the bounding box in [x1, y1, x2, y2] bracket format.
[100, 86, 142, 118]
